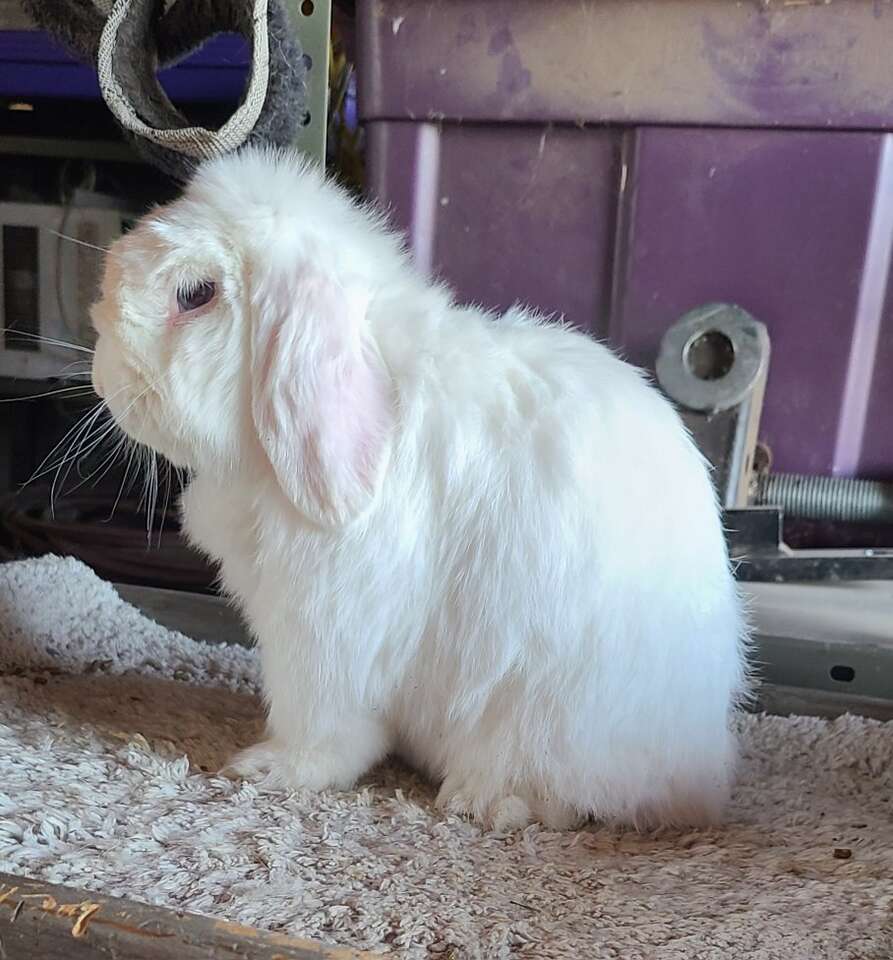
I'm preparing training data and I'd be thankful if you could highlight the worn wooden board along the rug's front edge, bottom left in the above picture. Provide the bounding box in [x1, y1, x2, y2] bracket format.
[0, 873, 372, 960]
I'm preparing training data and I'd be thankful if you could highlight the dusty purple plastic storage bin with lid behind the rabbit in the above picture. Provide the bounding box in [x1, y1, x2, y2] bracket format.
[357, 0, 893, 477]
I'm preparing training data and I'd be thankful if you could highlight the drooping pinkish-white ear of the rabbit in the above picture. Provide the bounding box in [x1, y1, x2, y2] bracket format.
[250, 267, 392, 525]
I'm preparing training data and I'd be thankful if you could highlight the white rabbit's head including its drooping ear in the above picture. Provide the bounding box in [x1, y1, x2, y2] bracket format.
[93, 150, 405, 523]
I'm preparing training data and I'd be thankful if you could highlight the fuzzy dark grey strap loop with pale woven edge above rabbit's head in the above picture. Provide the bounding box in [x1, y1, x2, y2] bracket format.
[23, 0, 306, 179]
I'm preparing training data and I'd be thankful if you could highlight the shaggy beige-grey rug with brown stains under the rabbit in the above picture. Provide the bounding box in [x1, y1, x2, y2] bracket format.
[0, 558, 893, 960]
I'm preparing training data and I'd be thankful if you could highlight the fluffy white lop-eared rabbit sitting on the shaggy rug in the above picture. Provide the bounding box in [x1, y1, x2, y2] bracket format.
[93, 150, 747, 830]
